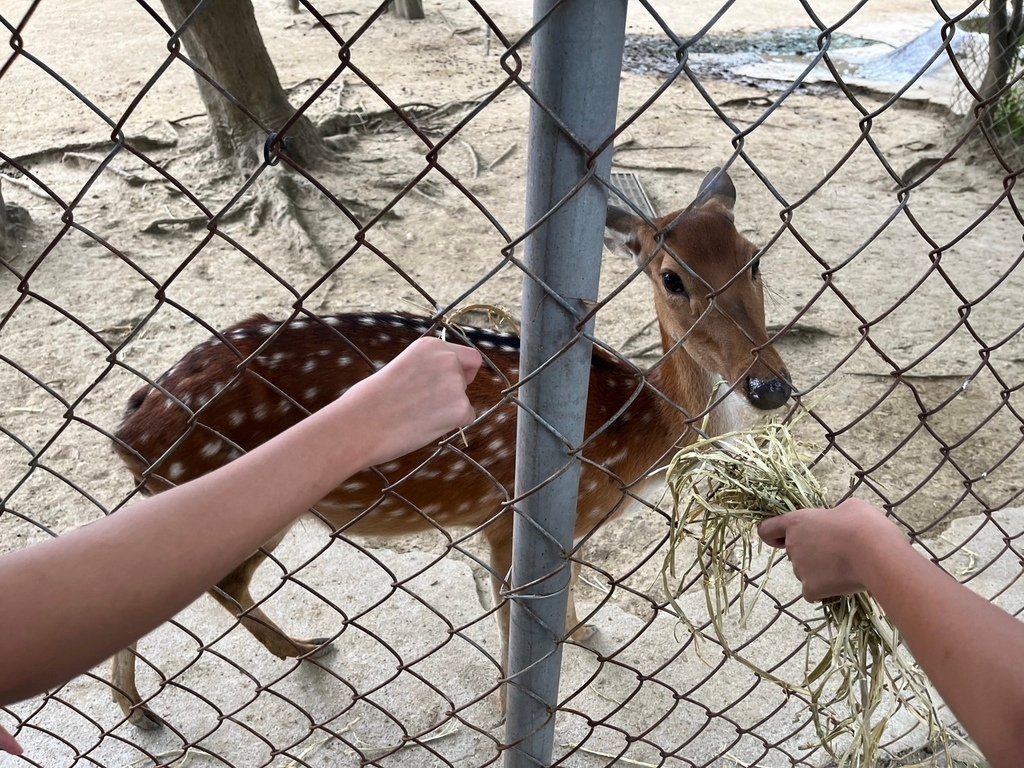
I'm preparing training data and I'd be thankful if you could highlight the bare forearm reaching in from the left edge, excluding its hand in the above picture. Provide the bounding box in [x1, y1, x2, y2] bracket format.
[0, 387, 374, 703]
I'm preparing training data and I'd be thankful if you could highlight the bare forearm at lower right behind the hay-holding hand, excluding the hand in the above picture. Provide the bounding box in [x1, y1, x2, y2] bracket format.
[864, 543, 1024, 768]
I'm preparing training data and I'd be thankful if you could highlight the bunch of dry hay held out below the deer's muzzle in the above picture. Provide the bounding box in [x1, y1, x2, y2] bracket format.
[662, 423, 948, 768]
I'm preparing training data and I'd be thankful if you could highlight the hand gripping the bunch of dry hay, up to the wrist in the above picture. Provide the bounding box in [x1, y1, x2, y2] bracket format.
[758, 499, 909, 601]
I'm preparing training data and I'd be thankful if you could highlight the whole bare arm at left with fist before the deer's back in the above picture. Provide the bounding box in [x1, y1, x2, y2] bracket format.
[0, 338, 480, 754]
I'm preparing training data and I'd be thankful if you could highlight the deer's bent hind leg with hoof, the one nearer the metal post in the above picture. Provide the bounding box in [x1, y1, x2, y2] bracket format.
[210, 548, 331, 658]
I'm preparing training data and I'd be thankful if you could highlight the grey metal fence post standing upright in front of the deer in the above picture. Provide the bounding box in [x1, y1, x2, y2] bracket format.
[505, 0, 626, 768]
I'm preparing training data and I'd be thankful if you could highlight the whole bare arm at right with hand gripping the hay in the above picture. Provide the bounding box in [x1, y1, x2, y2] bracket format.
[758, 500, 1024, 768]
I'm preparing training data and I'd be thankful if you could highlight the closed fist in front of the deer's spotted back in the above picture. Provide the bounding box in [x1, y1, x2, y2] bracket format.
[346, 337, 482, 464]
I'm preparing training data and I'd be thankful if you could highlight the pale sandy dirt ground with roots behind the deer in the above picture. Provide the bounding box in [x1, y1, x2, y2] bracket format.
[0, 0, 1024, 765]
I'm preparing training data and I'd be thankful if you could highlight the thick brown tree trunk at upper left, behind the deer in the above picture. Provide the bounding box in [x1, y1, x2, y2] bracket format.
[163, 0, 328, 170]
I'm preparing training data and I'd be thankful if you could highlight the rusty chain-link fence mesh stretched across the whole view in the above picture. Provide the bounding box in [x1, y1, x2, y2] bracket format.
[0, 0, 1024, 766]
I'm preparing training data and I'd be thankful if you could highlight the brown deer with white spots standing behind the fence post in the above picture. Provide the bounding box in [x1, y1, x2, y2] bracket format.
[113, 169, 791, 727]
